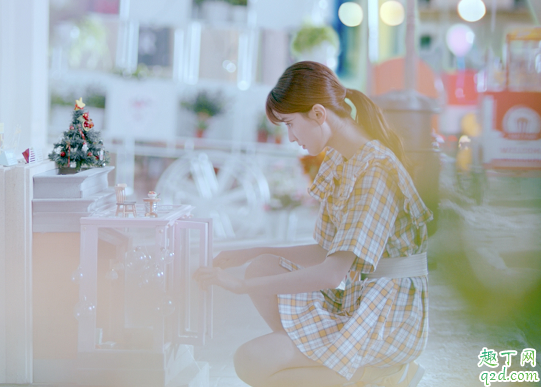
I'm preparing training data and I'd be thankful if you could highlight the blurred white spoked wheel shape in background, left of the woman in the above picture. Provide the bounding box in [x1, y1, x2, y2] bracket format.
[154, 151, 270, 240]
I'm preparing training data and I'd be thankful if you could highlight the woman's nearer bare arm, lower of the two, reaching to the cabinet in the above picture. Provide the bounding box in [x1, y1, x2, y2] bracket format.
[194, 251, 355, 295]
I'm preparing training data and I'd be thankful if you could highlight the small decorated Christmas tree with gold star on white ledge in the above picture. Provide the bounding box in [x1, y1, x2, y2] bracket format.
[49, 98, 109, 172]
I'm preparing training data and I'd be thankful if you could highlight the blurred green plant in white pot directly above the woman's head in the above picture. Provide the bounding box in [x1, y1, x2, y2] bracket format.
[291, 24, 340, 70]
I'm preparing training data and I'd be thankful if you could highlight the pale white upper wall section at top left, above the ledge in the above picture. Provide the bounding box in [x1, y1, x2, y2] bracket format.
[0, 0, 49, 156]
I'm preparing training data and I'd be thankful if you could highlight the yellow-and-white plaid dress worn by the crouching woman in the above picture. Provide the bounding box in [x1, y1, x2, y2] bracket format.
[278, 140, 432, 380]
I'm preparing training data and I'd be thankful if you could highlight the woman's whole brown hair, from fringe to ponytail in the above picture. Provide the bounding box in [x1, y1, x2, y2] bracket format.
[266, 61, 407, 164]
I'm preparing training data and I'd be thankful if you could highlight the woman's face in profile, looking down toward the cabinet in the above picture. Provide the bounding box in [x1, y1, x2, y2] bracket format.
[276, 111, 329, 156]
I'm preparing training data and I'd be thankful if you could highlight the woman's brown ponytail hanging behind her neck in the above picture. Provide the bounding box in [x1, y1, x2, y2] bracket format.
[346, 89, 408, 169]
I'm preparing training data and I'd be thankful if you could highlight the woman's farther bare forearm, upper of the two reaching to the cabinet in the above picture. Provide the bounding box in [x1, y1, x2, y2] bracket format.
[212, 244, 327, 269]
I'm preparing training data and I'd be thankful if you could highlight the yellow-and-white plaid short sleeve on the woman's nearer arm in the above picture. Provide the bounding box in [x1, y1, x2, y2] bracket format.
[328, 163, 401, 273]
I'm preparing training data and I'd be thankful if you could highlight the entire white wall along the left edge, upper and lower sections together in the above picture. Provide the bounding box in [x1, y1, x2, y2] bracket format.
[0, 0, 51, 383]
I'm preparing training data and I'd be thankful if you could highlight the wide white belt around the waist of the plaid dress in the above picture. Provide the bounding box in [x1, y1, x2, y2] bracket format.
[366, 253, 428, 278]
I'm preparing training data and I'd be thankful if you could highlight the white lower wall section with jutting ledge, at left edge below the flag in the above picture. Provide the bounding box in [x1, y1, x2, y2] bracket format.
[0, 161, 54, 384]
